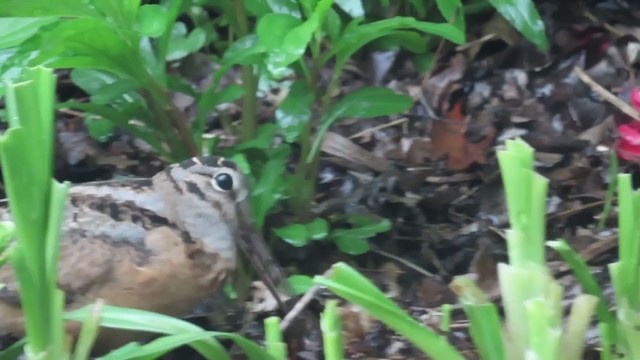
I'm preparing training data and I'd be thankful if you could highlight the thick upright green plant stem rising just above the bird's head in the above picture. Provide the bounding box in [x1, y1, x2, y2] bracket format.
[231, 0, 258, 141]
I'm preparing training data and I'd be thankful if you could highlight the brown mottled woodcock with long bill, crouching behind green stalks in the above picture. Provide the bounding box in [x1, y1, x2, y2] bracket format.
[0, 157, 281, 351]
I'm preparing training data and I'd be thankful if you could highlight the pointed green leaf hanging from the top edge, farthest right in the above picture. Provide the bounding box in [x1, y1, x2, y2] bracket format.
[489, 0, 549, 52]
